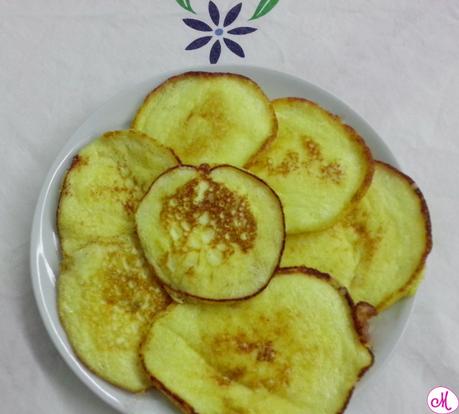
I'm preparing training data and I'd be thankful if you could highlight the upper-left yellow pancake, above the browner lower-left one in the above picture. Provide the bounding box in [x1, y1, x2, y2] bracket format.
[57, 130, 178, 253]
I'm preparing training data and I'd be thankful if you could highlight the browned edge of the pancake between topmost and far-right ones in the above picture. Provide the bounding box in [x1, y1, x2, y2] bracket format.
[246, 97, 375, 230]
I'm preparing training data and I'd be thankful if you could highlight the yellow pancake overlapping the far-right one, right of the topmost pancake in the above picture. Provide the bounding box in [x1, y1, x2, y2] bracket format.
[248, 98, 373, 234]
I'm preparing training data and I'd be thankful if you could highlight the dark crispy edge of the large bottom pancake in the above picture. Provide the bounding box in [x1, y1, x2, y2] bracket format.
[139, 266, 377, 414]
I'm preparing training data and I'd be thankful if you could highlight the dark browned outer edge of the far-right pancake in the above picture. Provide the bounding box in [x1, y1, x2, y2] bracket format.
[376, 161, 433, 311]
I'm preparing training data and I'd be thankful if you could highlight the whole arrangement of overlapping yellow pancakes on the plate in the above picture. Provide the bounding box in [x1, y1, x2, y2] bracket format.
[57, 72, 431, 414]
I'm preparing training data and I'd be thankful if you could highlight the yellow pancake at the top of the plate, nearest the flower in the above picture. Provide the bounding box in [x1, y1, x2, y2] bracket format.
[132, 72, 277, 167]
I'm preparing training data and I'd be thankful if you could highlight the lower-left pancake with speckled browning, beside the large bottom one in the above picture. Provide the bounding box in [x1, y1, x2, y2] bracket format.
[58, 236, 169, 392]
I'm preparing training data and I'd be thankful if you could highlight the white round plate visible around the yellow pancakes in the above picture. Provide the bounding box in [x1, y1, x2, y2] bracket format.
[30, 66, 413, 414]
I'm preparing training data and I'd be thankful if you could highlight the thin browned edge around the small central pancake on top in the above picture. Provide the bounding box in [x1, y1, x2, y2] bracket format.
[139, 164, 286, 303]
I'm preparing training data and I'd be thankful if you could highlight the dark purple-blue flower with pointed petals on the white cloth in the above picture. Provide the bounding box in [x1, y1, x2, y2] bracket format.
[183, 1, 257, 64]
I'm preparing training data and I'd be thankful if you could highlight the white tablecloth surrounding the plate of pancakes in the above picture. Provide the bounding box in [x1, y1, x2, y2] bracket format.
[0, 0, 459, 414]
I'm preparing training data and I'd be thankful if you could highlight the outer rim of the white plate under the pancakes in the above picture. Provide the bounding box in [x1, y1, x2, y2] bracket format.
[29, 64, 415, 414]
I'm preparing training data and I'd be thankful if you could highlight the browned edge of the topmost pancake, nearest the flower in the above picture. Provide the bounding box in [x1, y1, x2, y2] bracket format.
[131, 71, 278, 168]
